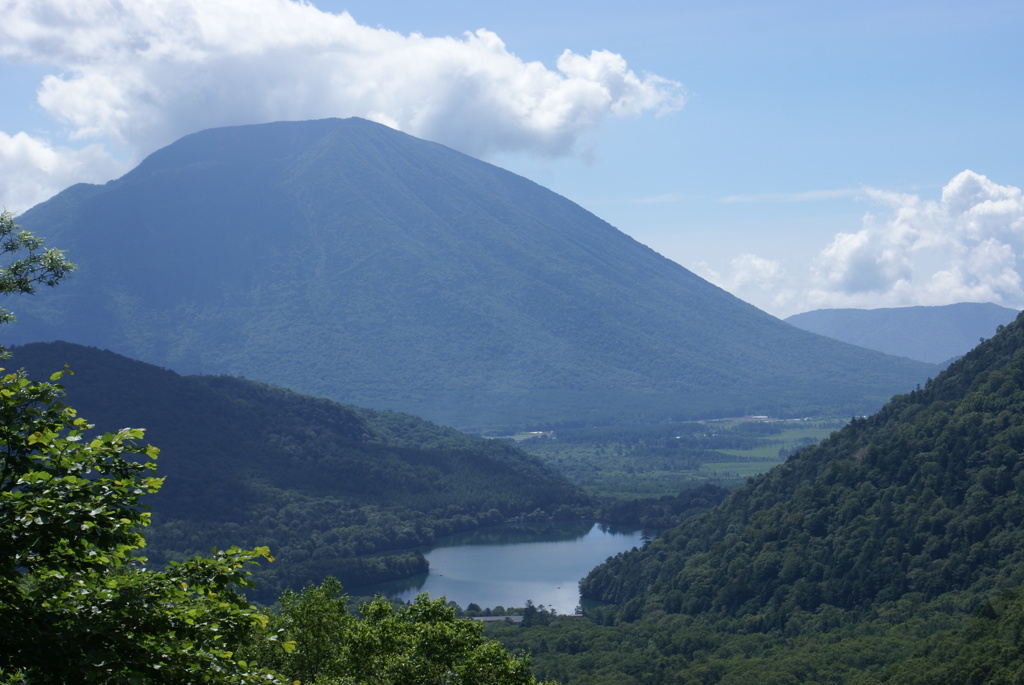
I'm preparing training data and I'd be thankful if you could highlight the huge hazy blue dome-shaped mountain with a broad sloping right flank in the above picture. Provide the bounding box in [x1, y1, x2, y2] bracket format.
[5, 119, 936, 430]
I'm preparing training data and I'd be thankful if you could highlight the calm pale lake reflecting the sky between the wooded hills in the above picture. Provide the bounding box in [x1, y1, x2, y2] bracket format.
[351, 522, 643, 613]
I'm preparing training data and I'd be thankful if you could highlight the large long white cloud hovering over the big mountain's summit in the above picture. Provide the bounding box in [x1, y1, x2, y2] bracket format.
[0, 0, 683, 205]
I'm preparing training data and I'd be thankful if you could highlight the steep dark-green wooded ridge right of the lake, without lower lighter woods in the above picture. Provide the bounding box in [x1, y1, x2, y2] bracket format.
[581, 318, 1024, 630]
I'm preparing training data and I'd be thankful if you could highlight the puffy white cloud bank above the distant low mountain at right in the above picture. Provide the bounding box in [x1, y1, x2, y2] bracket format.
[711, 171, 1024, 315]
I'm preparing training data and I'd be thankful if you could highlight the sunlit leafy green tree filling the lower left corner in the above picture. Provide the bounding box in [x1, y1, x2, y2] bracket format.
[0, 372, 279, 684]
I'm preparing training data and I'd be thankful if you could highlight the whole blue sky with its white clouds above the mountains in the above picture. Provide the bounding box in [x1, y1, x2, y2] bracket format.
[0, 0, 1024, 316]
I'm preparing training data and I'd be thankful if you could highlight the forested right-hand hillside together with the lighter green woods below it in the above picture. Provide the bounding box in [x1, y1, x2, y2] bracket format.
[477, 317, 1024, 685]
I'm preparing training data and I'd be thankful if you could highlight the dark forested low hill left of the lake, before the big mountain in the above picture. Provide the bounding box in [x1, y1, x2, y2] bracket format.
[5, 343, 588, 601]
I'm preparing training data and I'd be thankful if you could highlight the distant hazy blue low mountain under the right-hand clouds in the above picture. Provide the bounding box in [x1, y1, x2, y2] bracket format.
[785, 302, 1020, 363]
